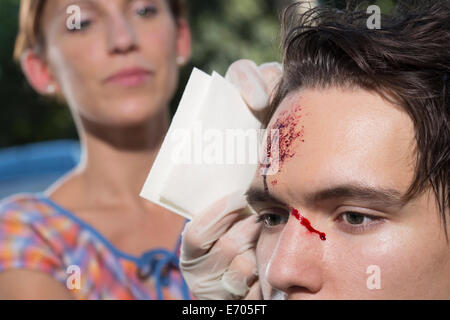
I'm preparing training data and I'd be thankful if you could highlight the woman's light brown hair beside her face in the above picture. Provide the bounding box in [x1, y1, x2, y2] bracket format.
[14, 0, 186, 61]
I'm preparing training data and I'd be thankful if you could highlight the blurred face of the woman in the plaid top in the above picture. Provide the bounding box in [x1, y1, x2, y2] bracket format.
[38, 0, 190, 126]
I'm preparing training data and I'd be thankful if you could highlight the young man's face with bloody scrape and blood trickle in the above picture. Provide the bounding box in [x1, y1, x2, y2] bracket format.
[248, 88, 450, 299]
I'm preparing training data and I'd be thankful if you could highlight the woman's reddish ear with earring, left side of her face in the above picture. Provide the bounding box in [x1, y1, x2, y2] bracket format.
[20, 50, 58, 95]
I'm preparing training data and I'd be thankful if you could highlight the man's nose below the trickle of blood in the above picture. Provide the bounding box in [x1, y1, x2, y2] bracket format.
[266, 215, 327, 294]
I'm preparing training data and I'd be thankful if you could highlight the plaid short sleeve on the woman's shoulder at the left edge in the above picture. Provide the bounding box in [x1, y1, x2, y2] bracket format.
[0, 194, 64, 281]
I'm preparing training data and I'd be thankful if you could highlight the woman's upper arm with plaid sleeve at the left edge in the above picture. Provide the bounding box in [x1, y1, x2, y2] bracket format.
[0, 196, 74, 299]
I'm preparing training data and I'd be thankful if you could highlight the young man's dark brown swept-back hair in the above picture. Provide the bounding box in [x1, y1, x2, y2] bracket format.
[263, 0, 450, 235]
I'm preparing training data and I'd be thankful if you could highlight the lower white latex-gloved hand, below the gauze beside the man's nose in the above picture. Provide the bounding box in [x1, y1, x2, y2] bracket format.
[180, 194, 261, 300]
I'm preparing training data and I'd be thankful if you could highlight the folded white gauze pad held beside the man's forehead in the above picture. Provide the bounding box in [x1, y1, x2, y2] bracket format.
[140, 68, 261, 219]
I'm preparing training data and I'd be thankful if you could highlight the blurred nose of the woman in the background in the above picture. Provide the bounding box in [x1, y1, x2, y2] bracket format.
[108, 16, 138, 54]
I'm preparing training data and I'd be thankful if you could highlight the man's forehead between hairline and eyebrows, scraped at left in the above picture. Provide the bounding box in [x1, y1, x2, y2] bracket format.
[256, 89, 414, 208]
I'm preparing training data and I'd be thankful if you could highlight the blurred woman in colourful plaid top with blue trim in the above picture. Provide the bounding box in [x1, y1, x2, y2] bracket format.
[0, 0, 191, 299]
